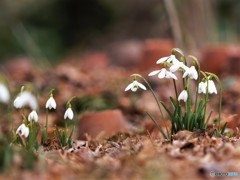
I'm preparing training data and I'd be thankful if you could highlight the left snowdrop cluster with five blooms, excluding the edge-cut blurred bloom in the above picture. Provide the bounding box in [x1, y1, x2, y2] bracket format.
[13, 87, 75, 150]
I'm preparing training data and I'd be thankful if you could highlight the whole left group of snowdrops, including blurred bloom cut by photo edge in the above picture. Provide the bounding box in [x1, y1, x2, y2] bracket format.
[0, 75, 75, 172]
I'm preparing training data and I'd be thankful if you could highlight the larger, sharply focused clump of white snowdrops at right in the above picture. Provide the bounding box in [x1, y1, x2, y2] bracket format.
[125, 48, 227, 140]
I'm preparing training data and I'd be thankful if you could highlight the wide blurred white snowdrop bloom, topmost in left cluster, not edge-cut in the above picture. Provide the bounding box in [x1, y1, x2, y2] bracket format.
[13, 91, 38, 110]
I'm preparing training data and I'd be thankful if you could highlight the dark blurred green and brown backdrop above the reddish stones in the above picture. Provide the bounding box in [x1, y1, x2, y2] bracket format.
[0, 0, 240, 66]
